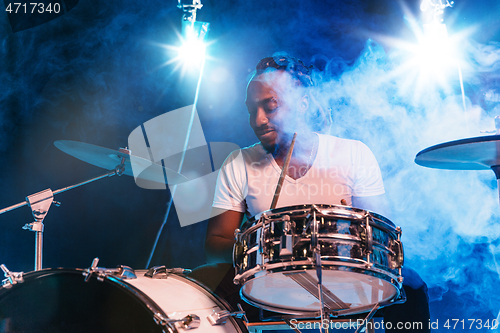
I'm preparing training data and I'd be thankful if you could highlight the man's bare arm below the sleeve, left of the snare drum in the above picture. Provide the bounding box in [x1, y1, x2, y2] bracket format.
[205, 208, 244, 264]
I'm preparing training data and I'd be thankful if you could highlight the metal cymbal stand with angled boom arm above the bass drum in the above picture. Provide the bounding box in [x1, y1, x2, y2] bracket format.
[0, 148, 130, 271]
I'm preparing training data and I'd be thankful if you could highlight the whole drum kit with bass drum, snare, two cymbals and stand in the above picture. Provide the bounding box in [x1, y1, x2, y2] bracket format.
[0, 126, 500, 333]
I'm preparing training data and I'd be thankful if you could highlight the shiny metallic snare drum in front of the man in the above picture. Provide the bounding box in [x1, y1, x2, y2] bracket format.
[233, 205, 404, 316]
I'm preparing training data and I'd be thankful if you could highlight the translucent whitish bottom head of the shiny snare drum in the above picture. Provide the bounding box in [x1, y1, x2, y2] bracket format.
[240, 270, 399, 314]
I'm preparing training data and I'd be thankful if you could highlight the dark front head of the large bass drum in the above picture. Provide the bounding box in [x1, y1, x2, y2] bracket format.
[0, 269, 168, 333]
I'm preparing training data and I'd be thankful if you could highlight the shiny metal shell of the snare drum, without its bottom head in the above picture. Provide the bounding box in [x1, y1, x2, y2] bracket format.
[235, 205, 400, 276]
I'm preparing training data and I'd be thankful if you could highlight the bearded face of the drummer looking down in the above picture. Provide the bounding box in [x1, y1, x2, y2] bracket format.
[245, 71, 301, 153]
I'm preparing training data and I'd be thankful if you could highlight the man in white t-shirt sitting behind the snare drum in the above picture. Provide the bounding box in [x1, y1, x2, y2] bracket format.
[197, 56, 429, 331]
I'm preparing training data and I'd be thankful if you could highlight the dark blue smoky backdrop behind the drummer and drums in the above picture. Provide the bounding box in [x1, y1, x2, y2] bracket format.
[0, 0, 500, 330]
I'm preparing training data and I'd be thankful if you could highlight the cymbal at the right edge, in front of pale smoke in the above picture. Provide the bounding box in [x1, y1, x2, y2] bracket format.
[415, 135, 500, 171]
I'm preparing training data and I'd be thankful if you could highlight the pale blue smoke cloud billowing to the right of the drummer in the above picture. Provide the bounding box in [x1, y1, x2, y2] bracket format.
[310, 41, 500, 322]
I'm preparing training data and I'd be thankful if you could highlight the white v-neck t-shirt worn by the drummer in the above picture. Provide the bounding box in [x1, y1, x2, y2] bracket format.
[213, 134, 385, 217]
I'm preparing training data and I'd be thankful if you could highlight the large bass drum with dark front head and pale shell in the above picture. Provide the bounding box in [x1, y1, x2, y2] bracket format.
[0, 266, 248, 333]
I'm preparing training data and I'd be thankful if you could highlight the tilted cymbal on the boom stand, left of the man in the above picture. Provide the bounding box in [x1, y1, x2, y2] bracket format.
[54, 140, 188, 185]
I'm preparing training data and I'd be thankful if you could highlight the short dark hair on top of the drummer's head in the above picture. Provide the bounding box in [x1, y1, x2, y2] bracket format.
[255, 55, 313, 87]
